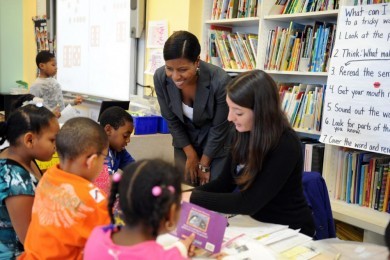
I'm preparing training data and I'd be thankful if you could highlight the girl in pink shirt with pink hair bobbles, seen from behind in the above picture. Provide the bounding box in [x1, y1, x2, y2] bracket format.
[84, 159, 195, 259]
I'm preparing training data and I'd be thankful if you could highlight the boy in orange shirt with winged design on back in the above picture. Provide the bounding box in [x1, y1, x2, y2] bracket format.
[20, 117, 110, 259]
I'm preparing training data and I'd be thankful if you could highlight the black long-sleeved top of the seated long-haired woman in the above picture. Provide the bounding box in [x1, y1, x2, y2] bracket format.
[190, 130, 314, 236]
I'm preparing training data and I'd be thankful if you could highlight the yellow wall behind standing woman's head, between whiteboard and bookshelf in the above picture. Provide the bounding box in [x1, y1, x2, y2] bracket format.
[143, 0, 203, 93]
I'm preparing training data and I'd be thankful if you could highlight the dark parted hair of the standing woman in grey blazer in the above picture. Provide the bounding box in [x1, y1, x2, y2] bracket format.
[163, 31, 200, 62]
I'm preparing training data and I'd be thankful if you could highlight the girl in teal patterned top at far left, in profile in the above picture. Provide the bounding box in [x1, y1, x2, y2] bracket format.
[0, 103, 59, 259]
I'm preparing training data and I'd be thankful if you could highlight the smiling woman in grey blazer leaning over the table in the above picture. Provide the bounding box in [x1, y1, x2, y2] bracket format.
[154, 31, 232, 185]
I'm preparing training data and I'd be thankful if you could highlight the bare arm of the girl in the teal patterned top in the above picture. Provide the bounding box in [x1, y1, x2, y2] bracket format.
[5, 195, 34, 244]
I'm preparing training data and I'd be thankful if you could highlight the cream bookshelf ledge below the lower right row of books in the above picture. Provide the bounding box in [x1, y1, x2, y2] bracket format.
[330, 199, 390, 235]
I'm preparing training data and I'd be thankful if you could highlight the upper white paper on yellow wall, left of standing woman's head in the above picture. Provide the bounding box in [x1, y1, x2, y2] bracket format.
[146, 20, 168, 48]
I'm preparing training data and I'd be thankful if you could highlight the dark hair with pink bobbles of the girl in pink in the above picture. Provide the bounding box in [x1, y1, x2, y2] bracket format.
[108, 159, 181, 237]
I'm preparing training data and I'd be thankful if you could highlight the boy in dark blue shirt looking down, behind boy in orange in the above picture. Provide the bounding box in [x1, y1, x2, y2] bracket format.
[95, 106, 135, 195]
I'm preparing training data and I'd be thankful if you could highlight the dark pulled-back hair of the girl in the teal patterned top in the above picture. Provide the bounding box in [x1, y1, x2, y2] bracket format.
[0, 104, 55, 145]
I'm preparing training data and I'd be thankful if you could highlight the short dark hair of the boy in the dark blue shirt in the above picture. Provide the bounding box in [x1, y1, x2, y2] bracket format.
[99, 106, 133, 130]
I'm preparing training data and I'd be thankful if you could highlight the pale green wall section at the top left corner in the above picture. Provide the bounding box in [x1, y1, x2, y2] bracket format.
[0, 0, 23, 92]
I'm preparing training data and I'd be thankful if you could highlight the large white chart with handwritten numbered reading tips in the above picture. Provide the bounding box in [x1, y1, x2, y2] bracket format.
[320, 4, 390, 154]
